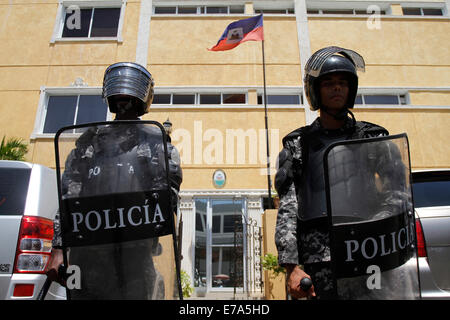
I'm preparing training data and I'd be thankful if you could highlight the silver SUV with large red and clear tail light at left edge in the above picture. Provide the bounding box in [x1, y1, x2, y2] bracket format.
[0, 160, 64, 300]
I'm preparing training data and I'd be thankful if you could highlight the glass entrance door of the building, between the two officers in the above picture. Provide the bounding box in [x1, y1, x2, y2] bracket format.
[195, 198, 245, 290]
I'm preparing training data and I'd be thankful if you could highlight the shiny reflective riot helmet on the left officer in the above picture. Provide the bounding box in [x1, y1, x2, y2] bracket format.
[102, 62, 154, 116]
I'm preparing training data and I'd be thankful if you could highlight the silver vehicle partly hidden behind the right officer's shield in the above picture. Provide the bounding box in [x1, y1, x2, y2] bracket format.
[412, 170, 450, 299]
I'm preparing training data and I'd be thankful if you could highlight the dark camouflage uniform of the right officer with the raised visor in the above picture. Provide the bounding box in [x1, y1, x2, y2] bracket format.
[275, 118, 389, 299]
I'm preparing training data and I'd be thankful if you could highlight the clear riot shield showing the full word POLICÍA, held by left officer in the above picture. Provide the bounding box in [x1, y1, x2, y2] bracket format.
[55, 121, 182, 300]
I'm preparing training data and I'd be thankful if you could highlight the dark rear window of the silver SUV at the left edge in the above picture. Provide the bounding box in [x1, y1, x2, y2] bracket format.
[0, 168, 31, 216]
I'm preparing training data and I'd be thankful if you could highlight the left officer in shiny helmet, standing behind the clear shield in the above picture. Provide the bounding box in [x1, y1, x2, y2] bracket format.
[49, 62, 182, 299]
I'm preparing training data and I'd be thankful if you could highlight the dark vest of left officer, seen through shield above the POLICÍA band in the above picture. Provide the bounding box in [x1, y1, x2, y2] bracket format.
[72, 126, 166, 196]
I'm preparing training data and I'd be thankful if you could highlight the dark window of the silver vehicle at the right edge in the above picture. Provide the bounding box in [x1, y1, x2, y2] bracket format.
[413, 172, 450, 208]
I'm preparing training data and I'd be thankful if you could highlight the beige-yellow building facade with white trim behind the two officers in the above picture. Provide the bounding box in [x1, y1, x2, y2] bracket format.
[0, 0, 450, 294]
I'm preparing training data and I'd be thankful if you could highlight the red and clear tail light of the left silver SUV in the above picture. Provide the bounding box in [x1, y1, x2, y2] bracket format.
[14, 216, 53, 273]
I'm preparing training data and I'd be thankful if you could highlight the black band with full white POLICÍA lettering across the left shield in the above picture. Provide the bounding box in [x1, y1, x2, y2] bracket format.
[62, 190, 173, 247]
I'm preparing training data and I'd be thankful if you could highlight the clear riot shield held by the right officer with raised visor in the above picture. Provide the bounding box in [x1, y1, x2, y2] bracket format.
[324, 134, 420, 300]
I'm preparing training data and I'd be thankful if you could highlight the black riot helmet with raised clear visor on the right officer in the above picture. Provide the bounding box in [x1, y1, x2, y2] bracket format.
[304, 46, 365, 111]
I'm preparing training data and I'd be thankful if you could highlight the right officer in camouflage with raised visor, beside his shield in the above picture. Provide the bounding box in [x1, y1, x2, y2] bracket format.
[275, 47, 388, 299]
